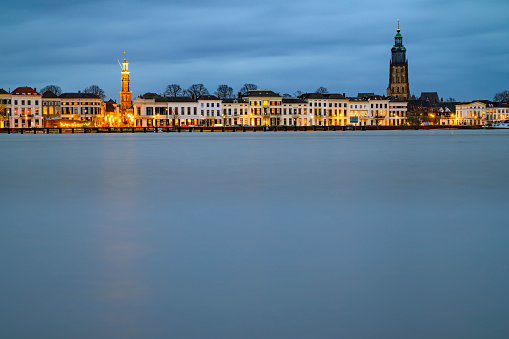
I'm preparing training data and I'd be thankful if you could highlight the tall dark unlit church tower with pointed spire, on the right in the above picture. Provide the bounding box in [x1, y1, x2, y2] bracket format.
[387, 19, 410, 101]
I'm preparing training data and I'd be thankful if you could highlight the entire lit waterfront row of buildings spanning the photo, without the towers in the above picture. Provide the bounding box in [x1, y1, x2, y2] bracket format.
[0, 87, 509, 128]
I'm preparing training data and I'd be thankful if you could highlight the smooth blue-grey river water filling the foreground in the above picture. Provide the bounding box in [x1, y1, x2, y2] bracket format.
[0, 130, 509, 338]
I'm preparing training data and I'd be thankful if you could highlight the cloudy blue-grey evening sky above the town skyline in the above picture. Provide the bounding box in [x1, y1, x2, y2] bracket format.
[0, 0, 509, 101]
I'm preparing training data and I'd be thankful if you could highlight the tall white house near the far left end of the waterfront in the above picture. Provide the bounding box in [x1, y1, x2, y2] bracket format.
[9, 87, 43, 128]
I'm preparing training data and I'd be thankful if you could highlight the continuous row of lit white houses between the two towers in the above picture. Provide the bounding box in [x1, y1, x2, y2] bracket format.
[133, 90, 407, 127]
